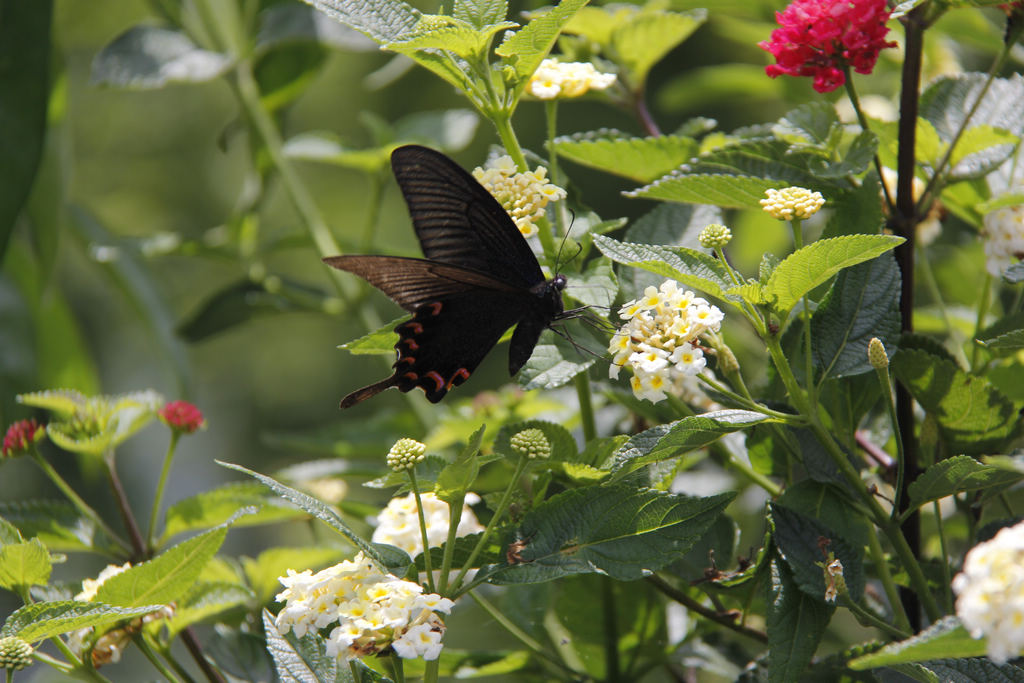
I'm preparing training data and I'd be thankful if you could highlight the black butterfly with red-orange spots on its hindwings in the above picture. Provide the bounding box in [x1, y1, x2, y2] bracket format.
[324, 144, 565, 408]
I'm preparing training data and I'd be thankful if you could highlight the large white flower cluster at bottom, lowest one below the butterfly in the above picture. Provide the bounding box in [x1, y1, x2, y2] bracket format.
[274, 553, 453, 659]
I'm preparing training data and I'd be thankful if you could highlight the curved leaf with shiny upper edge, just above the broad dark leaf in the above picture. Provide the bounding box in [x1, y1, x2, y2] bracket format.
[611, 410, 771, 481]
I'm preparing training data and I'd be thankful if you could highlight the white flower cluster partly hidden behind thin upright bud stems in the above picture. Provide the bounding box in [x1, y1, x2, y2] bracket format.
[373, 494, 483, 557]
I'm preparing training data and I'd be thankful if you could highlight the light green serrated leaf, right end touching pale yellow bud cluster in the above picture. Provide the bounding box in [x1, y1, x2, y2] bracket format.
[623, 172, 791, 209]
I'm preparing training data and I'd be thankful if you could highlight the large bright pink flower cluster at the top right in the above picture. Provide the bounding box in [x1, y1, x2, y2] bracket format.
[758, 0, 896, 92]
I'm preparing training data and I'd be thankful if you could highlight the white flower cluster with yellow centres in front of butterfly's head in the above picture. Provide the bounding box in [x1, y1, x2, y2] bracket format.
[608, 280, 724, 402]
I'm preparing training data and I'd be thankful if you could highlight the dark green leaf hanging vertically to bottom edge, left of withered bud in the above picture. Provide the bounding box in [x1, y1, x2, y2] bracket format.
[765, 559, 836, 683]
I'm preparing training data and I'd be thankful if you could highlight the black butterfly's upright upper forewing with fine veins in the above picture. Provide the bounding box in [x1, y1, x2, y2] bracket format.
[391, 144, 544, 289]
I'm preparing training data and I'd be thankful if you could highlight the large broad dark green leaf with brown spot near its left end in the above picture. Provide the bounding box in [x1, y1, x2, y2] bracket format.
[492, 484, 734, 584]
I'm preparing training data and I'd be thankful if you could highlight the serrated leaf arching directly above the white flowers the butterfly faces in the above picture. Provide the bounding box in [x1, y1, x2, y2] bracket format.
[594, 234, 737, 306]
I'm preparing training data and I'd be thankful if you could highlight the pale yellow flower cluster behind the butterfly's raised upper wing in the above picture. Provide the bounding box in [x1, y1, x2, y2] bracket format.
[473, 155, 565, 238]
